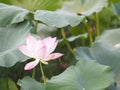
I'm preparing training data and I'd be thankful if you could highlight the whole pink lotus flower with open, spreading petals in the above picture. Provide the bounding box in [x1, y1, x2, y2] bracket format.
[18, 35, 63, 70]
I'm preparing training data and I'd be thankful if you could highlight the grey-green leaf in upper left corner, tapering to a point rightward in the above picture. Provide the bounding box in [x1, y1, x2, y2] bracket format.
[0, 3, 29, 27]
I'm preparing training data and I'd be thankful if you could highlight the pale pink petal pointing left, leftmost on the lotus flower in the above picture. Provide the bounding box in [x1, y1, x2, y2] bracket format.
[18, 45, 34, 58]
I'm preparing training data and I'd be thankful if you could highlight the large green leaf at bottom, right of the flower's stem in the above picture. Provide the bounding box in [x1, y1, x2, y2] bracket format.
[46, 60, 113, 90]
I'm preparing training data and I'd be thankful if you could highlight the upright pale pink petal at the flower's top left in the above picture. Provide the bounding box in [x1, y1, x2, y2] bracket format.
[26, 34, 37, 49]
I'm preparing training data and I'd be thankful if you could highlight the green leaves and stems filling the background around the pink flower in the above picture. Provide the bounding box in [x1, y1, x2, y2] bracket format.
[0, 0, 120, 90]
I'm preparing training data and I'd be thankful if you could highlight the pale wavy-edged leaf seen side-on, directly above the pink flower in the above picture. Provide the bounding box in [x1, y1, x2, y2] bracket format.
[35, 10, 84, 28]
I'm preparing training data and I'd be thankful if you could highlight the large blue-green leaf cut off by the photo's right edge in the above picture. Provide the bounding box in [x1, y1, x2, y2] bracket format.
[76, 29, 120, 82]
